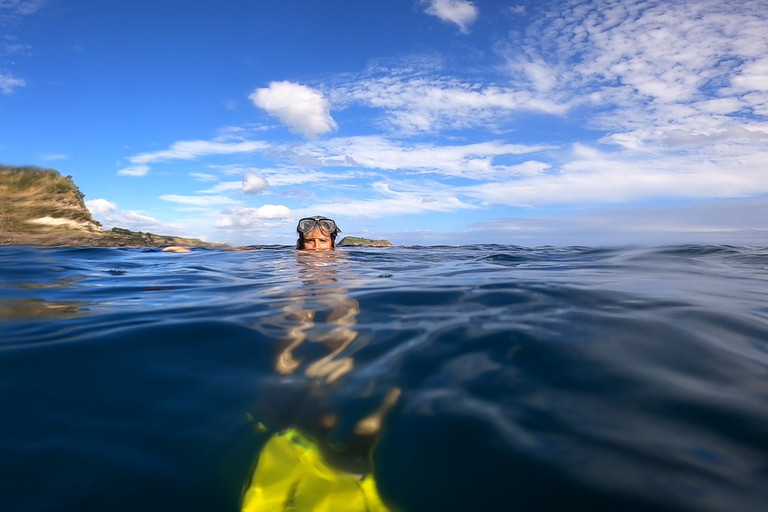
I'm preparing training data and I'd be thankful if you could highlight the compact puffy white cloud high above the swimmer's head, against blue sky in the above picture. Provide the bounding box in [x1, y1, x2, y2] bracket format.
[249, 82, 337, 139]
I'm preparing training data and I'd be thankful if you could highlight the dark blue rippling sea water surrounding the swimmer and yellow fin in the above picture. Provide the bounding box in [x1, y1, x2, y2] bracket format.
[0, 245, 768, 512]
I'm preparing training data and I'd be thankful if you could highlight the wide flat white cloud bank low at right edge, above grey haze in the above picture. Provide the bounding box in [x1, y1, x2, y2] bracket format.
[456, 144, 768, 207]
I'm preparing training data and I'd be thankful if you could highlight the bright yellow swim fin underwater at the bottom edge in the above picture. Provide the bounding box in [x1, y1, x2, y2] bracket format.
[241, 429, 392, 512]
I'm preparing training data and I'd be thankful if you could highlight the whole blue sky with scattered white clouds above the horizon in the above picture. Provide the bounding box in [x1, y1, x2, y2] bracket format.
[0, 0, 768, 247]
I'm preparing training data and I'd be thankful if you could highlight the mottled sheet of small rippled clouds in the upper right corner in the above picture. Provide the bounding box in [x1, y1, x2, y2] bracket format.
[498, 0, 768, 148]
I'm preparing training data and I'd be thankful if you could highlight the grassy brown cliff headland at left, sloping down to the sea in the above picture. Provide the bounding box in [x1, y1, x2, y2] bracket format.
[0, 165, 226, 247]
